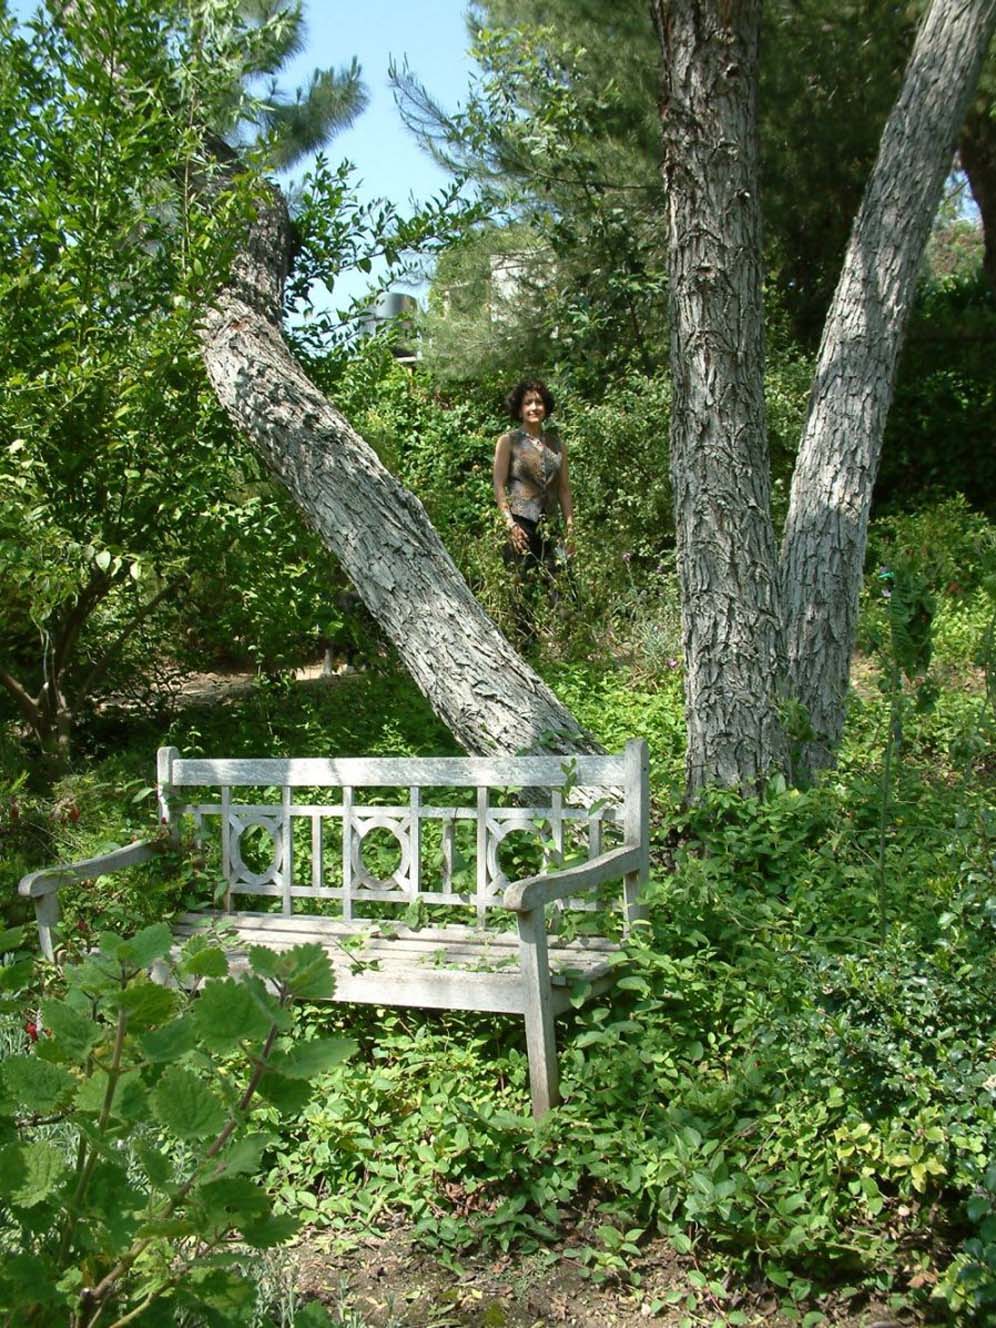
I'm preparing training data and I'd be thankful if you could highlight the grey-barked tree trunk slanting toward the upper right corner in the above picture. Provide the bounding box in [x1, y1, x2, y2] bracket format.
[781, 0, 996, 769]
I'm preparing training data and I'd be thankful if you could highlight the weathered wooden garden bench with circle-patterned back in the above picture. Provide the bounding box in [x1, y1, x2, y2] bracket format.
[20, 741, 649, 1117]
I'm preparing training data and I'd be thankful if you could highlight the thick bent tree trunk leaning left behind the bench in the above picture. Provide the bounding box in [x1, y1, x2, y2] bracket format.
[202, 163, 600, 754]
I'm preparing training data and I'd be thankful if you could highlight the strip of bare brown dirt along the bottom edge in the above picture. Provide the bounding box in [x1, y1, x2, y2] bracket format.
[286, 1228, 924, 1328]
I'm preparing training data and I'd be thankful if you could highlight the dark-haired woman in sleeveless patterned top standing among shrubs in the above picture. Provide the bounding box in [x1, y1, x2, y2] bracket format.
[493, 378, 574, 575]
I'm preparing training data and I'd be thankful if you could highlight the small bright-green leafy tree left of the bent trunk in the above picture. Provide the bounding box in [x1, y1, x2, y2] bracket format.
[0, 0, 361, 768]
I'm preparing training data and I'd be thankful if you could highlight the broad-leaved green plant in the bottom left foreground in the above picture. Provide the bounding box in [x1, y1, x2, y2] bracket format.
[0, 923, 352, 1328]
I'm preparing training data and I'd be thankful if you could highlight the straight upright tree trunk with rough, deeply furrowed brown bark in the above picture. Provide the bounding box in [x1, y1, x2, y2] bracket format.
[652, 0, 785, 793]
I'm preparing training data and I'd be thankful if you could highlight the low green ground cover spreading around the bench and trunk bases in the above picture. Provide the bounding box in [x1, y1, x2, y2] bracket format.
[4, 509, 996, 1328]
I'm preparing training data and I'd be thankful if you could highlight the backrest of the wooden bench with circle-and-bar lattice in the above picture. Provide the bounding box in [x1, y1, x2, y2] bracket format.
[158, 742, 647, 924]
